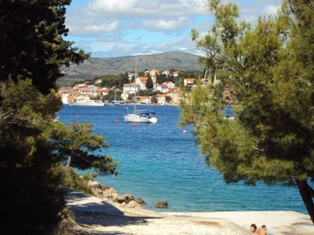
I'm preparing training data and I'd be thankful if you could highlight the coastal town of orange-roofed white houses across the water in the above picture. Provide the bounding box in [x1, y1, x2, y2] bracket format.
[58, 69, 221, 106]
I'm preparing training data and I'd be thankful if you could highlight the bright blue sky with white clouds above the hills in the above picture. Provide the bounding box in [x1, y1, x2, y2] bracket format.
[65, 0, 281, 57]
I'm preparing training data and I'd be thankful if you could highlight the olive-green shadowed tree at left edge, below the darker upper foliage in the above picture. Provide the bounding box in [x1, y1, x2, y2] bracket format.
[0, 80, 65, 234]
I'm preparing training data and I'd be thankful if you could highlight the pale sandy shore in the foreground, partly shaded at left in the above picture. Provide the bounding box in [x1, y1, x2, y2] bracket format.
[67, 189, 314, 235]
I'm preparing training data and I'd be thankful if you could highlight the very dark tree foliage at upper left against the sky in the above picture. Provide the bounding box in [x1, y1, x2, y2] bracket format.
[0, 0, 88, 94]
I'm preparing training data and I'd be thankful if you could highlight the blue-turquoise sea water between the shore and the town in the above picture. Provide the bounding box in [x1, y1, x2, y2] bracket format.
[58, 105, 307, 213]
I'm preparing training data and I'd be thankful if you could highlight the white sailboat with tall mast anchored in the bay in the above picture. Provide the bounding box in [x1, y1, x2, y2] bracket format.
[124, 56, 158, 124]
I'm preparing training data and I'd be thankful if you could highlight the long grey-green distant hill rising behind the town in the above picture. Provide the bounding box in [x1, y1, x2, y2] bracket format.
[59, 51, 203, 84]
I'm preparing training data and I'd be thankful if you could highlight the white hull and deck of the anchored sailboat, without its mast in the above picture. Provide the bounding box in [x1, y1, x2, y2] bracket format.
[124, 107, 158, 124]
